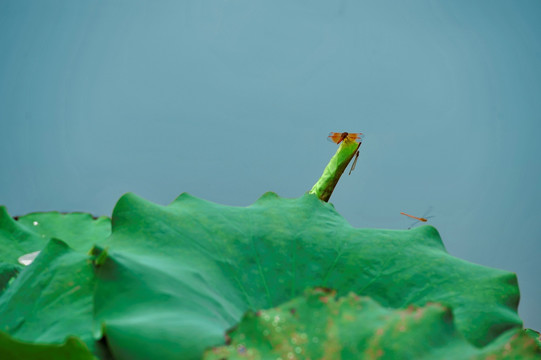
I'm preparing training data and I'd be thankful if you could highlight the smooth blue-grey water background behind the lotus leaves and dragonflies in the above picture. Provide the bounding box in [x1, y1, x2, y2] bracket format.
[0, 0, 541, 330]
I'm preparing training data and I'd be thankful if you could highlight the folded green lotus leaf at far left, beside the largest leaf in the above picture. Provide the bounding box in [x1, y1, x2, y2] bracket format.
[0, 239, 110, 359]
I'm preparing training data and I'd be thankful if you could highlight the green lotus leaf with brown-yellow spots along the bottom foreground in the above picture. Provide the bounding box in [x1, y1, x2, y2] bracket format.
[203, 288, 541, 360]
